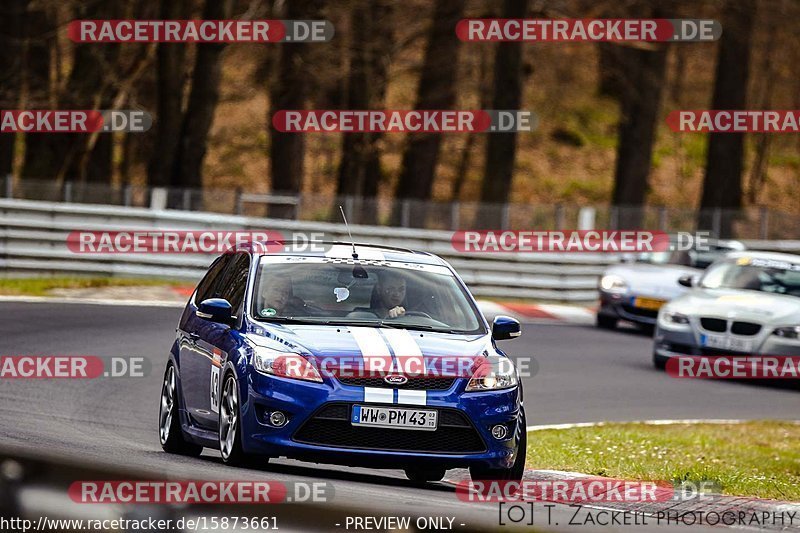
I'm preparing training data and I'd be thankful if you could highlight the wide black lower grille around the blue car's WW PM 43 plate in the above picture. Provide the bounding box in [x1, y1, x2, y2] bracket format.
[292, 403, 486, 454]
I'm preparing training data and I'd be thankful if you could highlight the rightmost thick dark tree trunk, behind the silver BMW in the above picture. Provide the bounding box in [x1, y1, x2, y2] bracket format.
[698, 0, 756, 237]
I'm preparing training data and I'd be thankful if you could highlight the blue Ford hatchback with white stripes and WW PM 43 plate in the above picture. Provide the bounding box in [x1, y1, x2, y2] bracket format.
[159, 243, 526, 482]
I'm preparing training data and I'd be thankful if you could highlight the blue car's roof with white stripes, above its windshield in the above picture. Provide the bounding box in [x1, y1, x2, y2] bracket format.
[239, 241, 447, 265]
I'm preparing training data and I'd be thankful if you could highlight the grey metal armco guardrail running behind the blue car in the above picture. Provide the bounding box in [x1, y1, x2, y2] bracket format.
[0, 199, 800, 303]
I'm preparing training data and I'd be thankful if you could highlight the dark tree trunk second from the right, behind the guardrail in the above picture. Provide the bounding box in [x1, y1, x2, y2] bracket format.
[612, 44, 667, 229]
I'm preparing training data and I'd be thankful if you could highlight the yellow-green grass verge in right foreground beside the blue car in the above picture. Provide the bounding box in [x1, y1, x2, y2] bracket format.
[527, 421, 800, 501]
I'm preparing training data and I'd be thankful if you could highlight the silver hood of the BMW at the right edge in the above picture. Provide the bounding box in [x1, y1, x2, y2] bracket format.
[667, 288, 800, 326]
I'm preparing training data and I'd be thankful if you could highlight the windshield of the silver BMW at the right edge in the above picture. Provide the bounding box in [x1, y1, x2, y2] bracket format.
[700, 257, 800, 296]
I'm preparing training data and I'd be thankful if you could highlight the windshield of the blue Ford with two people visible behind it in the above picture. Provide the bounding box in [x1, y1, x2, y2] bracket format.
[252, 256, 485, 333]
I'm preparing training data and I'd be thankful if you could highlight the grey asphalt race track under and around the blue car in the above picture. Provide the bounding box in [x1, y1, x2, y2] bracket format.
[0, 302, 800, 531]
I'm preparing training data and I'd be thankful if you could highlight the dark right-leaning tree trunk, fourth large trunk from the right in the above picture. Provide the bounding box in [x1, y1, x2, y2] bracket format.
[392, 0, 466, 223]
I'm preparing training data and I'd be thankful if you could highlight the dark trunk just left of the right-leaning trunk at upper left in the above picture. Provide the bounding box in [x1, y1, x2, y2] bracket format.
[147, 0, 188, 187]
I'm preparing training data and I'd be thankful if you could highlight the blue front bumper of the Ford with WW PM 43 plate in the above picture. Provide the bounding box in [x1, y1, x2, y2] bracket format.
[241, 369, 525, 468]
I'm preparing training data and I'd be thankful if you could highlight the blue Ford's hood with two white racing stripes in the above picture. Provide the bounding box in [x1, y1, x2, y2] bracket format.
[246, 324, 494, 358]
